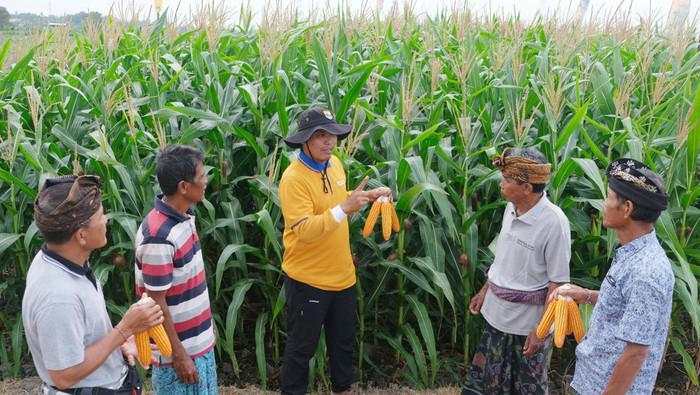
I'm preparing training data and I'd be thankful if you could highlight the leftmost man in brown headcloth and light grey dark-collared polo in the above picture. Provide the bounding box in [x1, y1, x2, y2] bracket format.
[22, 176, 163, 395]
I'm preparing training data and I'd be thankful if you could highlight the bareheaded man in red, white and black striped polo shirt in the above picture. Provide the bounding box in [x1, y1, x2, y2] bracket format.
[135, 145, 217, 394]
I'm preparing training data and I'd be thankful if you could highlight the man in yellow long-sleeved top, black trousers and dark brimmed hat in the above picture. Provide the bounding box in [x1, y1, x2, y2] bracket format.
[279, 107, 391, 394]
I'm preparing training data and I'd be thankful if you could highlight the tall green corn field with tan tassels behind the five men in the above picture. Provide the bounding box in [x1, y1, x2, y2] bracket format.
[0, 6, 700, 390]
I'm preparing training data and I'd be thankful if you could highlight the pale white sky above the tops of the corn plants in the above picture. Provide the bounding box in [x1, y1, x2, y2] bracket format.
[0, 0, 700, 24]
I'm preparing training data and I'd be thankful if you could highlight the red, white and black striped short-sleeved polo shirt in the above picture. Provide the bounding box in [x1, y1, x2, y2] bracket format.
[135, 196, 214, 364]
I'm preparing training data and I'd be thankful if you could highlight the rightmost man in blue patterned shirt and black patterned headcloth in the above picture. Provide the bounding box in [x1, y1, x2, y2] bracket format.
[553, 159, 674, 394]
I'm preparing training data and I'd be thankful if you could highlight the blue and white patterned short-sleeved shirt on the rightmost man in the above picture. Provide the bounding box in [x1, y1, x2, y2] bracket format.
[571, 231, 675, 395]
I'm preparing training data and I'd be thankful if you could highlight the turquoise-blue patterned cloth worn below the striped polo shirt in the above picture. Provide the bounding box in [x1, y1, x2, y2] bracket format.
[152, 349, 219, 395]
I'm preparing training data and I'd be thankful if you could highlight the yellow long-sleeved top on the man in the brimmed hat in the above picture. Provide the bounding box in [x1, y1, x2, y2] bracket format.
[279, 156, 355, 291]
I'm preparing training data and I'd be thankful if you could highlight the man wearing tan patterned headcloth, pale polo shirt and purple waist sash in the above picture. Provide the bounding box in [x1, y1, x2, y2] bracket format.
[462, 148, 571, 394]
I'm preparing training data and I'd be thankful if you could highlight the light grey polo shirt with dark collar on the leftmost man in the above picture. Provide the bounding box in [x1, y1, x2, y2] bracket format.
[22, 249, 128, 389]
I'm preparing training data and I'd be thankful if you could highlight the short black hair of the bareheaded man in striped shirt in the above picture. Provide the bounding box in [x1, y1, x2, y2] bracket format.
[156, 144, 204, 196]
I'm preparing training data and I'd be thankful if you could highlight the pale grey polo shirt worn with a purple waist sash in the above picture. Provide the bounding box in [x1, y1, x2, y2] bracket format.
[481, 193, 571, 336]
